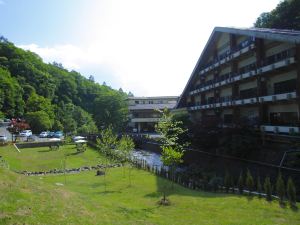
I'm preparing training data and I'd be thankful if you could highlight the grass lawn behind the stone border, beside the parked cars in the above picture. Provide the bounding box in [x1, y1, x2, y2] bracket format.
[0, 145, 104, 171]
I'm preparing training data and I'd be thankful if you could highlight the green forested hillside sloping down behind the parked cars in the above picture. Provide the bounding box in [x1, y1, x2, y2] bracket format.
[0, 37, 127, 133]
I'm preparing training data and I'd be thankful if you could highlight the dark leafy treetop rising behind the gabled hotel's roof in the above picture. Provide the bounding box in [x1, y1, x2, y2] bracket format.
[254, 0, 300, 30]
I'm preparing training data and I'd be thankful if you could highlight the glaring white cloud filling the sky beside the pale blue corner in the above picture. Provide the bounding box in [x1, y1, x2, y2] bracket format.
[18, 0, 279, 96]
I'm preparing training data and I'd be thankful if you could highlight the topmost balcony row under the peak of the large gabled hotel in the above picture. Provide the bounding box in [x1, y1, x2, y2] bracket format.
[199, 37, 255, 75]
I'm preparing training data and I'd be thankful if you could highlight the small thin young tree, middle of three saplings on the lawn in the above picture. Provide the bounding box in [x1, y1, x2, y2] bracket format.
[117, 135, 135, 186]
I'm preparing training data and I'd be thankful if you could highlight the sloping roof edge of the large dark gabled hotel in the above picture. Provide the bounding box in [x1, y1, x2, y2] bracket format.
[176, 27, 300, 108]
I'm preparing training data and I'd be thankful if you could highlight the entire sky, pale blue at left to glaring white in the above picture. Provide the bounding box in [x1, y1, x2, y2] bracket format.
[0, 0, 280, 96]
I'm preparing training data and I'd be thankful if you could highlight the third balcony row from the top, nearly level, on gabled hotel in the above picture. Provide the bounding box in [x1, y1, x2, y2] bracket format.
[188, 92, 297, 111]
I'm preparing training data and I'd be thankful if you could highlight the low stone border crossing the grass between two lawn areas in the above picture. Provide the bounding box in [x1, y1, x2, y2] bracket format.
[15, 164, 122, 176]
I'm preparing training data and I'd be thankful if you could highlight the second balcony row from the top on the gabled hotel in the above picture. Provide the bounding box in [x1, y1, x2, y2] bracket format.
[189, 49, 295, 95]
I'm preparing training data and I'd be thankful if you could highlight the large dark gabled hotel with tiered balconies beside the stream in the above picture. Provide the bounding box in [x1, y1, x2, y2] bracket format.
[176, 27, 300, 134]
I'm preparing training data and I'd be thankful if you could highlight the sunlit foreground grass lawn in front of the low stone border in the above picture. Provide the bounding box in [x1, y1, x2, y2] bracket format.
[0, 168, 300, 225]
